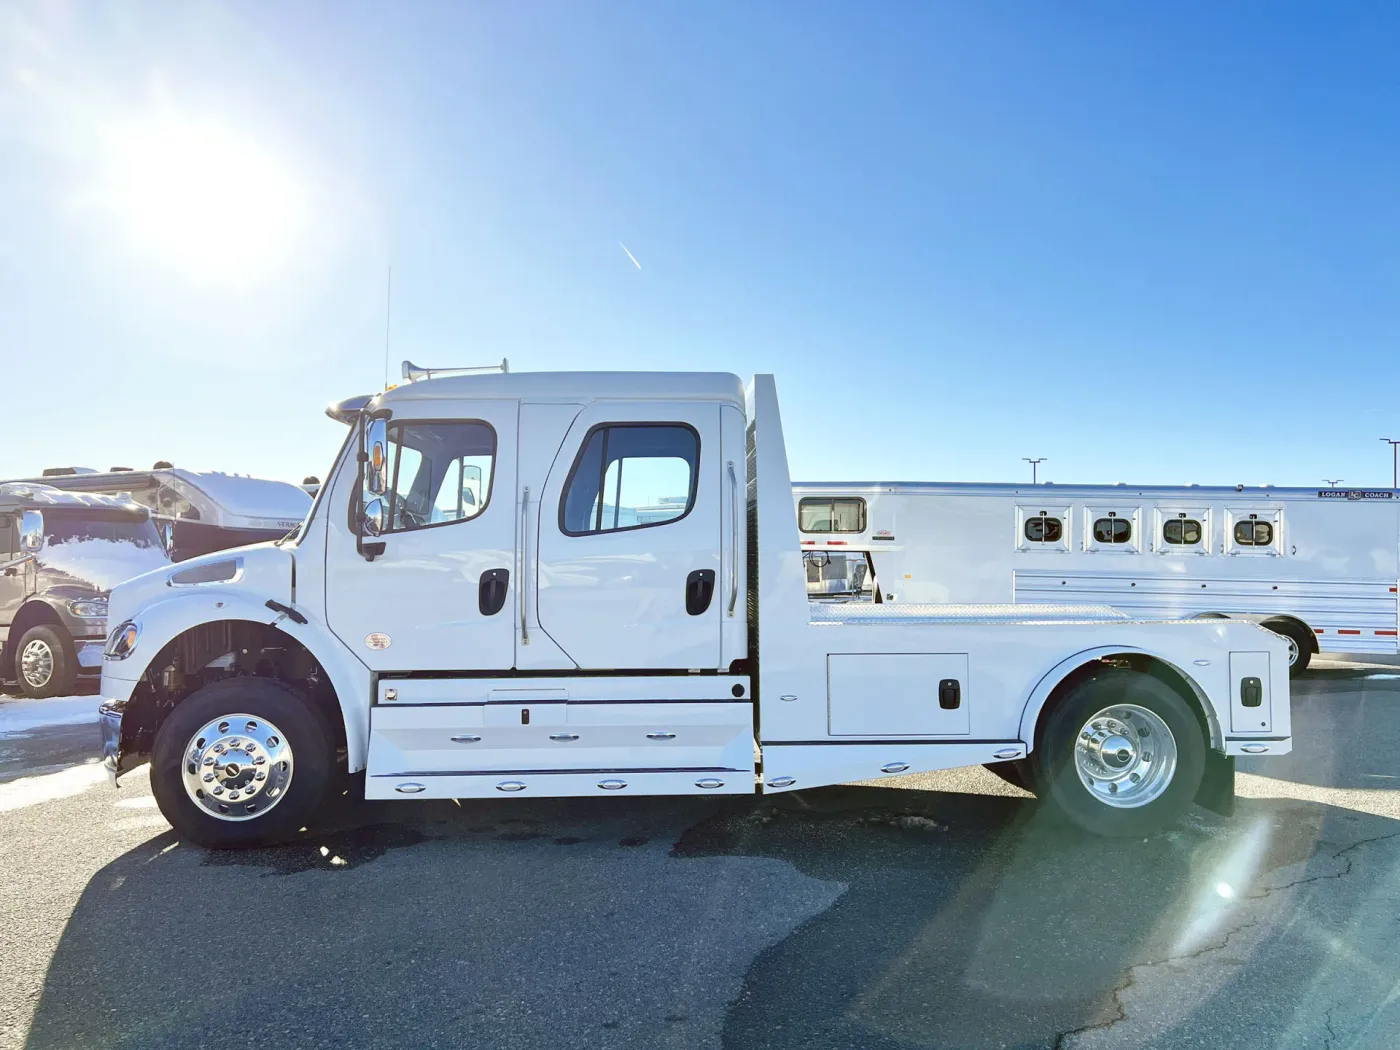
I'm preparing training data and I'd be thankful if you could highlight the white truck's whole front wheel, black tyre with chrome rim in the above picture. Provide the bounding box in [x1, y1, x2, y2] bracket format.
[151, 678, 335, 850]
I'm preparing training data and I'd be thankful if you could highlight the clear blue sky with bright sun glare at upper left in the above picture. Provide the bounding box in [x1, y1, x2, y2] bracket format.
[0, 1, 1400, 486]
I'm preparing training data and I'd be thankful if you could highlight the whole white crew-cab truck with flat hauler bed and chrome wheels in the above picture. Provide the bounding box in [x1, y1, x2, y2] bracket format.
[101, 372, 1291, 847]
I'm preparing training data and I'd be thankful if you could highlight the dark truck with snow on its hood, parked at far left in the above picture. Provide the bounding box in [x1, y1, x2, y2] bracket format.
[0, 483, 169, 697]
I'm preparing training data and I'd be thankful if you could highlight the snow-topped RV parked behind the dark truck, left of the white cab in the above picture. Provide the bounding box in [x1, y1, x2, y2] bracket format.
[18, 461, 311, 561]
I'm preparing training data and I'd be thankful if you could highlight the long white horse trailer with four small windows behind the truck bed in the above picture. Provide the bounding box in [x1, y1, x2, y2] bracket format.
[794, 482, 1400, 673]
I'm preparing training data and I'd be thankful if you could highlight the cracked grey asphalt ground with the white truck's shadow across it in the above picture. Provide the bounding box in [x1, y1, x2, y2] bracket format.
[0, 662, 1400, 1050]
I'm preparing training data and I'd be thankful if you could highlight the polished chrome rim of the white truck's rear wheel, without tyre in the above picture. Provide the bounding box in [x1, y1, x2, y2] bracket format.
[1074, 704, 1176, 809]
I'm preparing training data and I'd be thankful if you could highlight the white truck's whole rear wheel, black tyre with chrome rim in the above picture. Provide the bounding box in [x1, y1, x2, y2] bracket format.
[1032, 669, 1207, 836]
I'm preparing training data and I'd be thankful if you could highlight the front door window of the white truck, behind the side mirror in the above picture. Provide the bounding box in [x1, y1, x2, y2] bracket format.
[385, 420, 496, 532]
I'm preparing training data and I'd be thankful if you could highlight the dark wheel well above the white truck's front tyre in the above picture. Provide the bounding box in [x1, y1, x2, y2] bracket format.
[119, 620, 346, 770]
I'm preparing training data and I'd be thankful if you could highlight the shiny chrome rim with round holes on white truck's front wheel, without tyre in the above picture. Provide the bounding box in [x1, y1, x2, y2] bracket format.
[182, 714, 291, 820]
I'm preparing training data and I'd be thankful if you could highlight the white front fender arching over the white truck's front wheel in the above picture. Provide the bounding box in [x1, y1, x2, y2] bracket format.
[102, 588, 371, 773]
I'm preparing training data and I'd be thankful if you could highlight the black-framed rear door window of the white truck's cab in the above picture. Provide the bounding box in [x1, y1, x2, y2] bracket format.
[559, 423, 700, 536]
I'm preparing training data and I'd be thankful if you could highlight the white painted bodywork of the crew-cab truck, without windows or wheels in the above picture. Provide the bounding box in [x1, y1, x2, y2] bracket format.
[104, 374, 1291, 798]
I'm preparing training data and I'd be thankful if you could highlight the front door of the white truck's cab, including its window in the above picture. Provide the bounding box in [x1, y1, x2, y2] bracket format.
[325, 400, 519, 671]
